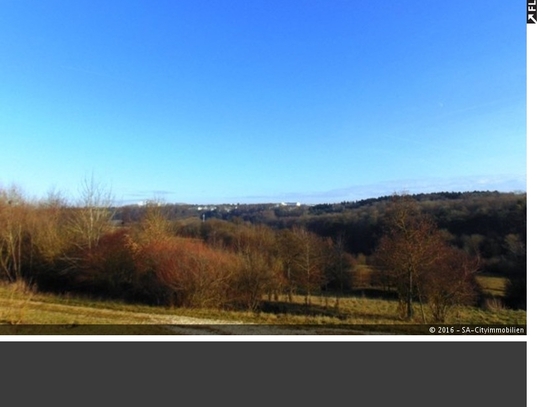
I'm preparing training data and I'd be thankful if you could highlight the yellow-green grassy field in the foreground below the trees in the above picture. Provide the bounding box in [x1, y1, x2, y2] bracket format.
[0, 278, 526, 335]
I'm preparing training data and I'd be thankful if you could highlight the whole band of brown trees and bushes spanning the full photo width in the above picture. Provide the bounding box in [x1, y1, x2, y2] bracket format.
[0, 179, 526, 320]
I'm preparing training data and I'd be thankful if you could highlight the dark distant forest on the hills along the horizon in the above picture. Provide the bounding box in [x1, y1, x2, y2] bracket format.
[118, 191, 526, 274]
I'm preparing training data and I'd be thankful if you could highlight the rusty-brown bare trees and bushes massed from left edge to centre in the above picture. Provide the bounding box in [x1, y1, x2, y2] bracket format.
[0, 181, 352, 310]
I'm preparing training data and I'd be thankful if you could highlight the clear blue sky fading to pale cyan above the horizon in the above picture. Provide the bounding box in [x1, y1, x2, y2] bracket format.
[0, 0, 527, 204]
